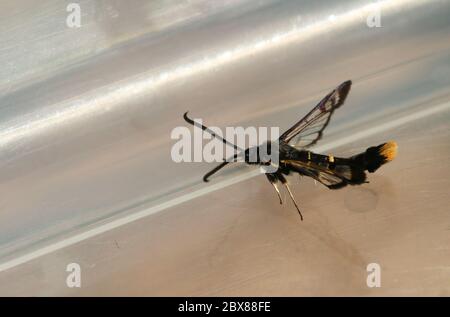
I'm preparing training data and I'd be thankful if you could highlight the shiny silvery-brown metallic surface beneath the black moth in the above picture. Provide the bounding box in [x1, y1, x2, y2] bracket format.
[0, 0, 450, 295]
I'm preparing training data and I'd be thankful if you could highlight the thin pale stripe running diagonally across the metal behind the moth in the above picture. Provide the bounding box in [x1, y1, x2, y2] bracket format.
[0, 102, 450, 272]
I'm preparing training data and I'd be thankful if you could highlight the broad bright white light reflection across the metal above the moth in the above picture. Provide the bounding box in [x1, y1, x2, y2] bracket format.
[0, 0, 414, 147]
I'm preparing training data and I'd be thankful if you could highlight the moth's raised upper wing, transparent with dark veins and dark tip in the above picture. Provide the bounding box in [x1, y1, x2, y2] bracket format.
[280, 80, 352, 147]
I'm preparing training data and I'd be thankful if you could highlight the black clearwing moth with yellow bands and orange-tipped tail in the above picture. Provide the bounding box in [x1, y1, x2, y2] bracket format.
[183, 80, 397, 220]
